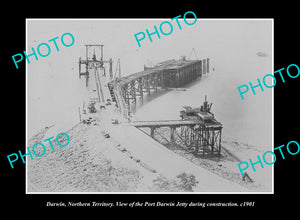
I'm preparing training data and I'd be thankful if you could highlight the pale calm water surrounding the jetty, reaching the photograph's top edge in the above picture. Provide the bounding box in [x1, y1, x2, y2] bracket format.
[27, 19, 272, 150]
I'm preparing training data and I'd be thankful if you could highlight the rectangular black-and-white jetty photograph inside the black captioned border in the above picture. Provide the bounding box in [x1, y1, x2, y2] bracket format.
[26, 19, 273, 194]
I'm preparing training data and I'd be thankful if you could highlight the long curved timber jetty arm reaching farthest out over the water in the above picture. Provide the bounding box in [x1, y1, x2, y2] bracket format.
[108, 59, 209, 111]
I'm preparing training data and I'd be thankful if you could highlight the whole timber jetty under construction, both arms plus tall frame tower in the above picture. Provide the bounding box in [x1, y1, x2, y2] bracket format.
[79, 45, 223, 155]
